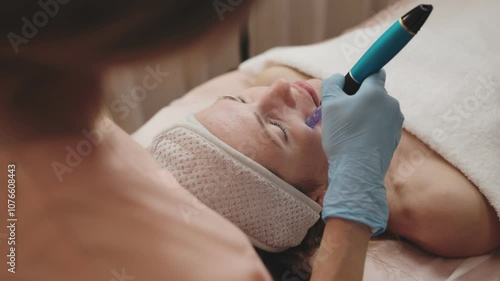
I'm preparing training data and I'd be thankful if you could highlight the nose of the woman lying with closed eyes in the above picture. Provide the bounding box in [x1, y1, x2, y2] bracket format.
[260, 79, 295, 112]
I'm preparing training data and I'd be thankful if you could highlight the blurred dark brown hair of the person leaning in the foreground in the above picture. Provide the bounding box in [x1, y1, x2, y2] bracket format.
[0, 0, 252, 137]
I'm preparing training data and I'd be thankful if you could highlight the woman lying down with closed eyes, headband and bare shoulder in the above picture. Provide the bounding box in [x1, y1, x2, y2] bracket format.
[150, 67, 500, 278]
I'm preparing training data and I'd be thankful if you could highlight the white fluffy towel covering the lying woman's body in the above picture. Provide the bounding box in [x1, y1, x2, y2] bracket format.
[239, 0, 500, 217]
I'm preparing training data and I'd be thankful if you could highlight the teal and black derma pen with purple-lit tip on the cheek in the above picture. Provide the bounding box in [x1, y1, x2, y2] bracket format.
[306, 5, 432, 128]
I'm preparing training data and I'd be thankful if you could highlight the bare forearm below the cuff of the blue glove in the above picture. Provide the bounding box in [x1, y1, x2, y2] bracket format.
[311, 218, 371, 281]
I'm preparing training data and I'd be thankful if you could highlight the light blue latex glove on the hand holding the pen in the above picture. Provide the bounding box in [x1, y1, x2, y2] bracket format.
[321, 70, 404, 236]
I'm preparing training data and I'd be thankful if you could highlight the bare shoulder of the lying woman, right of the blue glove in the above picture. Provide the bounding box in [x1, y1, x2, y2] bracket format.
[387, 131, 500, 257]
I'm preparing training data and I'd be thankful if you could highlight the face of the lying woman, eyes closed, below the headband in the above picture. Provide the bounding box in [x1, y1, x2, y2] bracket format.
[195, 79, 328, 203]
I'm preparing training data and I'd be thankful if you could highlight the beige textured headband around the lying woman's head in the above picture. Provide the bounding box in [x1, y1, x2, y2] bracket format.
[150, 117, 321, 252]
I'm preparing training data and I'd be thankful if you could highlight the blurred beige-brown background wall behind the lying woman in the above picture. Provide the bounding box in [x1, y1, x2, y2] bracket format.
[105, 0, 396, 133]
